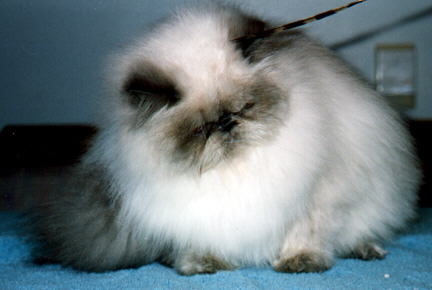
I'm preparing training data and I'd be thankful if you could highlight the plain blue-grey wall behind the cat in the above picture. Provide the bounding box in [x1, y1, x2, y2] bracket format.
[0, 0, 432, 128]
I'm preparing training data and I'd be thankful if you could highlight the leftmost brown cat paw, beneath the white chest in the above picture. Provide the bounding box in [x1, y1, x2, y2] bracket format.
[174, 253, 234, 276]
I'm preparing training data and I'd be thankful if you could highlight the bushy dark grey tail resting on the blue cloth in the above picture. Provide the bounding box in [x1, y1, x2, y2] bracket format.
[33, 166, 163, 272]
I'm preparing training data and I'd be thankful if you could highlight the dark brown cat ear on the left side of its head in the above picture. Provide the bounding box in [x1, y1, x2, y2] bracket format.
[122, 64, 180, 112]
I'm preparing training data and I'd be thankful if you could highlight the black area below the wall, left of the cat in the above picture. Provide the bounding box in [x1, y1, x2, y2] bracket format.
[0, 125, 97, 211]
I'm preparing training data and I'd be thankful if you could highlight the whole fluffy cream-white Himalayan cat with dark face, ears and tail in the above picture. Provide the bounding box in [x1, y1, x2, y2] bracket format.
[36, 4, 420, 275]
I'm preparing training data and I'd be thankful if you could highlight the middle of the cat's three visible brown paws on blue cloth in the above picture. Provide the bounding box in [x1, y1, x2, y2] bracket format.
[273, 251, 333, 273]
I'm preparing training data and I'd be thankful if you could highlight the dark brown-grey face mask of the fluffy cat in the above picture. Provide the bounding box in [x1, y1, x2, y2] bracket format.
[167, 80, 281, 171]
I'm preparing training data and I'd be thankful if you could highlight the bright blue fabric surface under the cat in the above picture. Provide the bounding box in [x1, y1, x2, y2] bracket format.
[0, 209, 432, 290]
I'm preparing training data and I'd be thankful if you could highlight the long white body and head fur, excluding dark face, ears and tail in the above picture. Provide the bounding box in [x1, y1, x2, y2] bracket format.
[87, 3, 419, 265]
